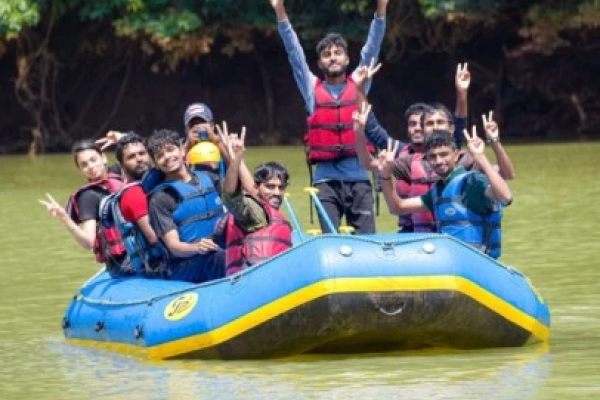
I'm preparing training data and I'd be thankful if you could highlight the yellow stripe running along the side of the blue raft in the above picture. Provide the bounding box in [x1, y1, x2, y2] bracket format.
[67, 276, 550, 359]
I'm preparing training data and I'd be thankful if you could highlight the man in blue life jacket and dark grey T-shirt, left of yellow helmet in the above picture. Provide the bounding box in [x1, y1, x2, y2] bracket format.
[142, 129, 225, 283]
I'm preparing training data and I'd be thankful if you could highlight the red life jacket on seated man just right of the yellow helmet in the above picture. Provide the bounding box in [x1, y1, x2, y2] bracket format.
[225, 199, 292, 275]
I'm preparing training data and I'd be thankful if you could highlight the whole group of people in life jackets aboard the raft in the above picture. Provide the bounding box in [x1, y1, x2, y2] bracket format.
[40, 0, 514, 283]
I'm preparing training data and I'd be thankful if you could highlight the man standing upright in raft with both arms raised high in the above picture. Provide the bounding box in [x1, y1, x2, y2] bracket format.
[270, 0, 388, 234]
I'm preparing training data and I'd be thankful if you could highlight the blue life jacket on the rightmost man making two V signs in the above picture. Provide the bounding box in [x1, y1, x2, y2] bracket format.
[431, 171, 502, 258]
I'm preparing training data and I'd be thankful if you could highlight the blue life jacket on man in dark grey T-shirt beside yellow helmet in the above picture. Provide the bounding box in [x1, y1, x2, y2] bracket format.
[148, 171, 224, 264]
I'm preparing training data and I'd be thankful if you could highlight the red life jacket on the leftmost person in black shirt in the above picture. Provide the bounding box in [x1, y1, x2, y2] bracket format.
[66, 173, 126, 263]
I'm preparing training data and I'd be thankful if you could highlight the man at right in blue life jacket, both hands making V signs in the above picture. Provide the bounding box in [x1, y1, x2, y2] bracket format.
[378, 127, 512, 258]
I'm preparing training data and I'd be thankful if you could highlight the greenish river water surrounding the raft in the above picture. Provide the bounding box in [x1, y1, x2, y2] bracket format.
[0, 144, 600, 400]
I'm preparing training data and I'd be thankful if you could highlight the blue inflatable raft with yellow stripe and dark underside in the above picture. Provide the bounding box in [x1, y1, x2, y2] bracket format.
[63, 234, 550, 359]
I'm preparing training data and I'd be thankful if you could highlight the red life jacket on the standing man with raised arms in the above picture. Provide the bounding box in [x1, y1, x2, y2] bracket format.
[304, 77, 375, 163]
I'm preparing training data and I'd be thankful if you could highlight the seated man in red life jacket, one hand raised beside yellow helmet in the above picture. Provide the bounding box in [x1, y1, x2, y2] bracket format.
[215, 132, 292, 275]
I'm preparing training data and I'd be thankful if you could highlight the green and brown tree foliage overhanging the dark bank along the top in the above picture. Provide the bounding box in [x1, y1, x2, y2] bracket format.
[0, 0, 600, 151]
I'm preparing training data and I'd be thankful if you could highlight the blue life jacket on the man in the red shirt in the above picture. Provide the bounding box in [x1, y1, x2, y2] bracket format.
[100, 182, 165, 276]
